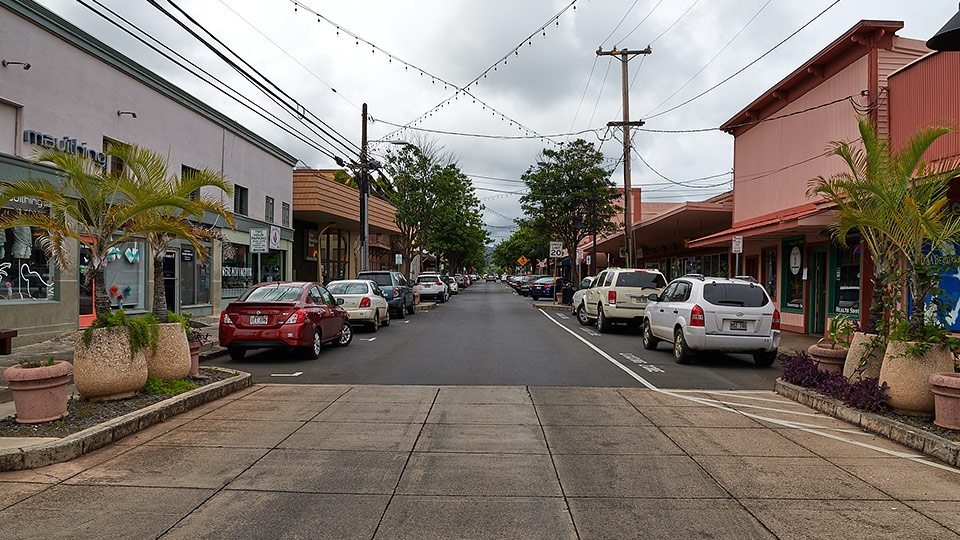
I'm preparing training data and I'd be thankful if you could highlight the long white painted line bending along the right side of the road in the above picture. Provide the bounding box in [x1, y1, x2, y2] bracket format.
[539, 309, 960, 474]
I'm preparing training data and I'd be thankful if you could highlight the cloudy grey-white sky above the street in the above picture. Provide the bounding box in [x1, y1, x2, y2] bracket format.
[40, 0, 957, 240]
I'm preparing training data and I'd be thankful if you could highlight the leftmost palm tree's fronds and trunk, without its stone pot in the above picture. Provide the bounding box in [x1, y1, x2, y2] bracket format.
[0, 148, 199, 314]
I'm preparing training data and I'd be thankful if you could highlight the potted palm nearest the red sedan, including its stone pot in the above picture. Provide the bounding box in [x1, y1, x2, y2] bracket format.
[107, 145, 233, 380]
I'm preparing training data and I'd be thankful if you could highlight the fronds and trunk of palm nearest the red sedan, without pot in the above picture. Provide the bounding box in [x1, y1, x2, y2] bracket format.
[114, 145, 233, 322]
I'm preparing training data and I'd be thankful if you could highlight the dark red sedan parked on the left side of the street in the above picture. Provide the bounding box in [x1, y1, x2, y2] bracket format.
[219, 281, 353, 360]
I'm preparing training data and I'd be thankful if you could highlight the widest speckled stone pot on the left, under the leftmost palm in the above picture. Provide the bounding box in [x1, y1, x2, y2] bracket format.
[73, 327, 147, 401]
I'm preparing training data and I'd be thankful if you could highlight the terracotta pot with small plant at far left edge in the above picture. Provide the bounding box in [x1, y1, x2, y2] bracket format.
[3, 360, 73, 424]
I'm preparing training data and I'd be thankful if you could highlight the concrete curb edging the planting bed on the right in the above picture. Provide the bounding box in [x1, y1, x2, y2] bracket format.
[774, 379, 960, 467]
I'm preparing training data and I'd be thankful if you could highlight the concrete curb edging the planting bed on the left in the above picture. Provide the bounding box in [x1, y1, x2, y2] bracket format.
[0, 368, 253, 471]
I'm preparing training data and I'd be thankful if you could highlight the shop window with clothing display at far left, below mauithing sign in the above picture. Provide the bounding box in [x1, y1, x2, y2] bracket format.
[0, 223, 60, 302]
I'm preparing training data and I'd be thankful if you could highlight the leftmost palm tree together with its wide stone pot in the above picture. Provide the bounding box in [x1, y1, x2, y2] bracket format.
[0, 146, 201, 398]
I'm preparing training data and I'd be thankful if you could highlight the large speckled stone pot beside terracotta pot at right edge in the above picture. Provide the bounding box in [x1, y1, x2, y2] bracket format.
[880, 341, 954, 416]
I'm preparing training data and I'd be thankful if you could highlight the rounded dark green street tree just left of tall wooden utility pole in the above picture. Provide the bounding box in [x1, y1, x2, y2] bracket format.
[520, 139, 620, 282]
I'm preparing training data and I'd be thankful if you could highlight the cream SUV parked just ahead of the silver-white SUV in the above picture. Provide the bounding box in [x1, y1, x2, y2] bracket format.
[578, 268, 667, 332]
